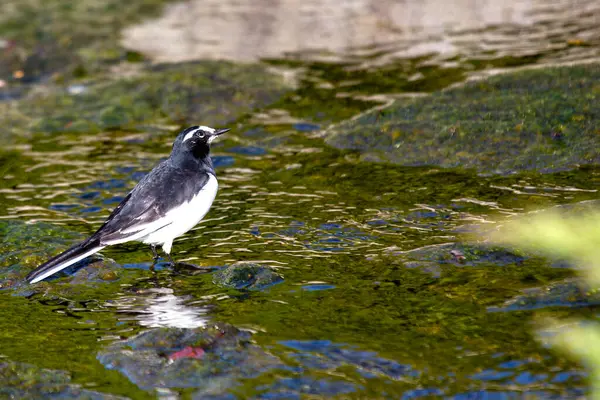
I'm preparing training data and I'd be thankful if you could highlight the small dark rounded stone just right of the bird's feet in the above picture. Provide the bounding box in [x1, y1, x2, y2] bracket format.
[213, 263, 283, 290]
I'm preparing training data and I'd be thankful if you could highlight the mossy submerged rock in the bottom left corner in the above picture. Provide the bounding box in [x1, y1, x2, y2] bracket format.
[0, 361, 126, 400]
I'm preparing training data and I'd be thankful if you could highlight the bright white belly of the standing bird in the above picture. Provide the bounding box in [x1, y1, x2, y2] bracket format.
[138, 174, 219, 248]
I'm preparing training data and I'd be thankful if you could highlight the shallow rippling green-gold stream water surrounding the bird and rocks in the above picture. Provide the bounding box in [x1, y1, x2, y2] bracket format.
[0, 2, 600, 399]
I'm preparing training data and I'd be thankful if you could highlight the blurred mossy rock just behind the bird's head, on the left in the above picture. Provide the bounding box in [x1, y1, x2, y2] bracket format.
[0, 62, 286, 140]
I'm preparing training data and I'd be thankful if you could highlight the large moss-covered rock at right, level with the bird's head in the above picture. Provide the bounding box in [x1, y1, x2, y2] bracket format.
[326, 64, 600, 173]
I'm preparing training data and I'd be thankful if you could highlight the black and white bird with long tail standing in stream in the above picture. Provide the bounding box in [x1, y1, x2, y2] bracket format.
[27, 126, 229, 283]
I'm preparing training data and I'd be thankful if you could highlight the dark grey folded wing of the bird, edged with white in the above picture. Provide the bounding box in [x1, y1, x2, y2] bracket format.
[90, 160, 209, 244]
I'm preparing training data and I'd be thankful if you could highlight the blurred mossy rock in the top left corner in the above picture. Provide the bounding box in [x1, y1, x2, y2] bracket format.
[0, 0, 176, 83]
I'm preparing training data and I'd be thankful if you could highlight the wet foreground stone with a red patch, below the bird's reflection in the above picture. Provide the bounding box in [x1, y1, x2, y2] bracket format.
[97, 325, 280, 395]
